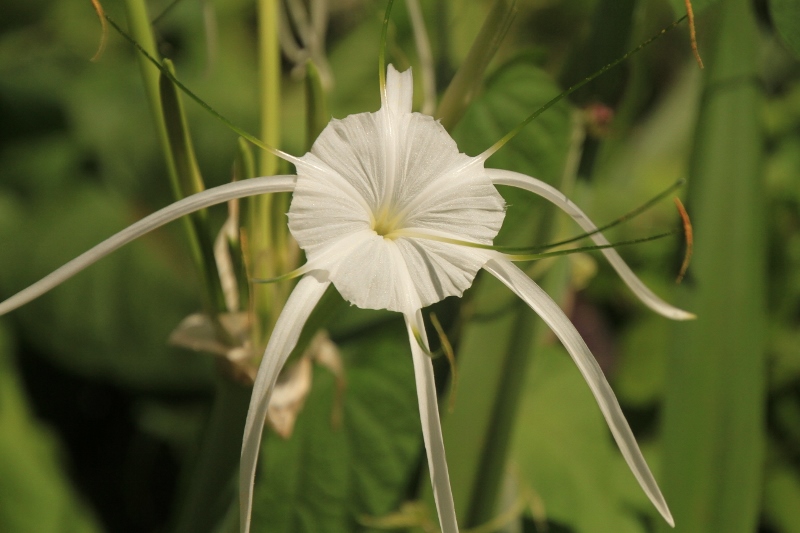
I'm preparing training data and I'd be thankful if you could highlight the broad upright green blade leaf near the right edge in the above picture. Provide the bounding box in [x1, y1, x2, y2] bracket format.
[660, 0, 766, 533]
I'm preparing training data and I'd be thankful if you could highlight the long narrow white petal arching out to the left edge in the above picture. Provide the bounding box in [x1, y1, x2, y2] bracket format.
[0, 176, 296, 315]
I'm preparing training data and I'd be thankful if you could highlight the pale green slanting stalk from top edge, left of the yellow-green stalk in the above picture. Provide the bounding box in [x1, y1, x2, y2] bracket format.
[125, 0, 209, 304]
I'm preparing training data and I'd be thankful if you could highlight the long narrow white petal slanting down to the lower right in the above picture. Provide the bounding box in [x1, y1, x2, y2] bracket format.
[484, 259, 675, 526]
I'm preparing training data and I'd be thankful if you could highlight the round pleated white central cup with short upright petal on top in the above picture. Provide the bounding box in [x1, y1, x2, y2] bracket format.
[288, 67, 505, 313]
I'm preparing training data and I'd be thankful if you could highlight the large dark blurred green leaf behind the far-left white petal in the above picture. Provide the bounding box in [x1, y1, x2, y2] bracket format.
[0, 186, 211, 390]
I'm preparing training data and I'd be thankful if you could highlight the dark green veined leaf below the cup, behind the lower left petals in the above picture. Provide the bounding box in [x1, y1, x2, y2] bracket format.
[252, 322, 422, 533]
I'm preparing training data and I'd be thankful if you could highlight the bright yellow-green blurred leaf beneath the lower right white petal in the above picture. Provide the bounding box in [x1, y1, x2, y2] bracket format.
[513, 344, 652, 533]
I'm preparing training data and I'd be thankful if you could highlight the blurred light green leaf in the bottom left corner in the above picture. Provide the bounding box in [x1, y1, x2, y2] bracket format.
[0, 326, 101, 533]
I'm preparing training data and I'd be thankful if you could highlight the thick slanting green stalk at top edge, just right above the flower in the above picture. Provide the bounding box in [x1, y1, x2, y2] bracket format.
[434, 0, 517, 131]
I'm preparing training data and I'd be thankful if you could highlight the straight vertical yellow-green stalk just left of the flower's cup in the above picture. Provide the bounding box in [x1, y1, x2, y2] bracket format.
[252, 0, 286, 347]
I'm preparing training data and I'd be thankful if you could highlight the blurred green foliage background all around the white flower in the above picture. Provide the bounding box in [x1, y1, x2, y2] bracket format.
[0, 0, 800, 533]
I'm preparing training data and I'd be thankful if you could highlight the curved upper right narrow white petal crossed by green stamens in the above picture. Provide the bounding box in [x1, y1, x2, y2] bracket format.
[486, 168, 696, 320]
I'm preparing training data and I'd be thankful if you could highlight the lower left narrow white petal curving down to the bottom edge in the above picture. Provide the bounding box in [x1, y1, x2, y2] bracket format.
[239, 273, 330, 533]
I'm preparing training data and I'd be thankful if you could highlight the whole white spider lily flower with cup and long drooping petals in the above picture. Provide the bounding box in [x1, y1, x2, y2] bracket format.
[0, 65, 694, 533]
